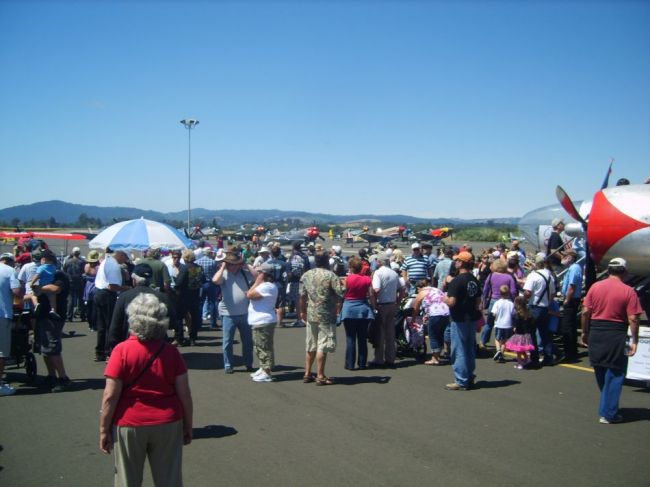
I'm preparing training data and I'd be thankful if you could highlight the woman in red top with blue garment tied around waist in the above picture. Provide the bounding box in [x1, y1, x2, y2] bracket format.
[341, 257, 375, 370]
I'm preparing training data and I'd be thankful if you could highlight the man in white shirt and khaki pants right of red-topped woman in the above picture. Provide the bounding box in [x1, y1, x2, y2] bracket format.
[369, 254, 404, 367]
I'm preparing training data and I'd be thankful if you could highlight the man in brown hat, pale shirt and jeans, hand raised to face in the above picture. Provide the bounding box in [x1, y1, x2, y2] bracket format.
[212, 247, 254, 374]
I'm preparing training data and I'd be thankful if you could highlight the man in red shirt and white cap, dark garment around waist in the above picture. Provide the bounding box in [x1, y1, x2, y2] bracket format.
[581, 257, 643, 424]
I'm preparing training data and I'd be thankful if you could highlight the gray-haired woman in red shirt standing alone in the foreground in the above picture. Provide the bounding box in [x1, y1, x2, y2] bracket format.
[99, 294, 192, 487]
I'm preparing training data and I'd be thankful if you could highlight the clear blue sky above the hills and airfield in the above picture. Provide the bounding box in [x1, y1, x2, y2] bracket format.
[0, 0, 650, 218]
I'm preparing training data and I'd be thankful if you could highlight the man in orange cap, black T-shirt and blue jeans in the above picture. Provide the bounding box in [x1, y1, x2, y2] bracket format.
[445, 252, 481, 391]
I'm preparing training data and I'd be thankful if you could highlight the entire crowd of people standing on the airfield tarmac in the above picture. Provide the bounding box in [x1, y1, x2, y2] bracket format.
[0, 221, 641, 482]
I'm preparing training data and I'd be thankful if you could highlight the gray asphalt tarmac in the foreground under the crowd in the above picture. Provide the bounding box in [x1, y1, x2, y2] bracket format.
[0, 236, 650, 487]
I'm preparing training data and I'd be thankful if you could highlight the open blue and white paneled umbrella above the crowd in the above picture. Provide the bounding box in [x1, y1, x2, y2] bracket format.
[88, 218, 192, 250]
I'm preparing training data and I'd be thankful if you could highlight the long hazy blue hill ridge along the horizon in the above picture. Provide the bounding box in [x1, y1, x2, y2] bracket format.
[0, 200, 519, 225]
